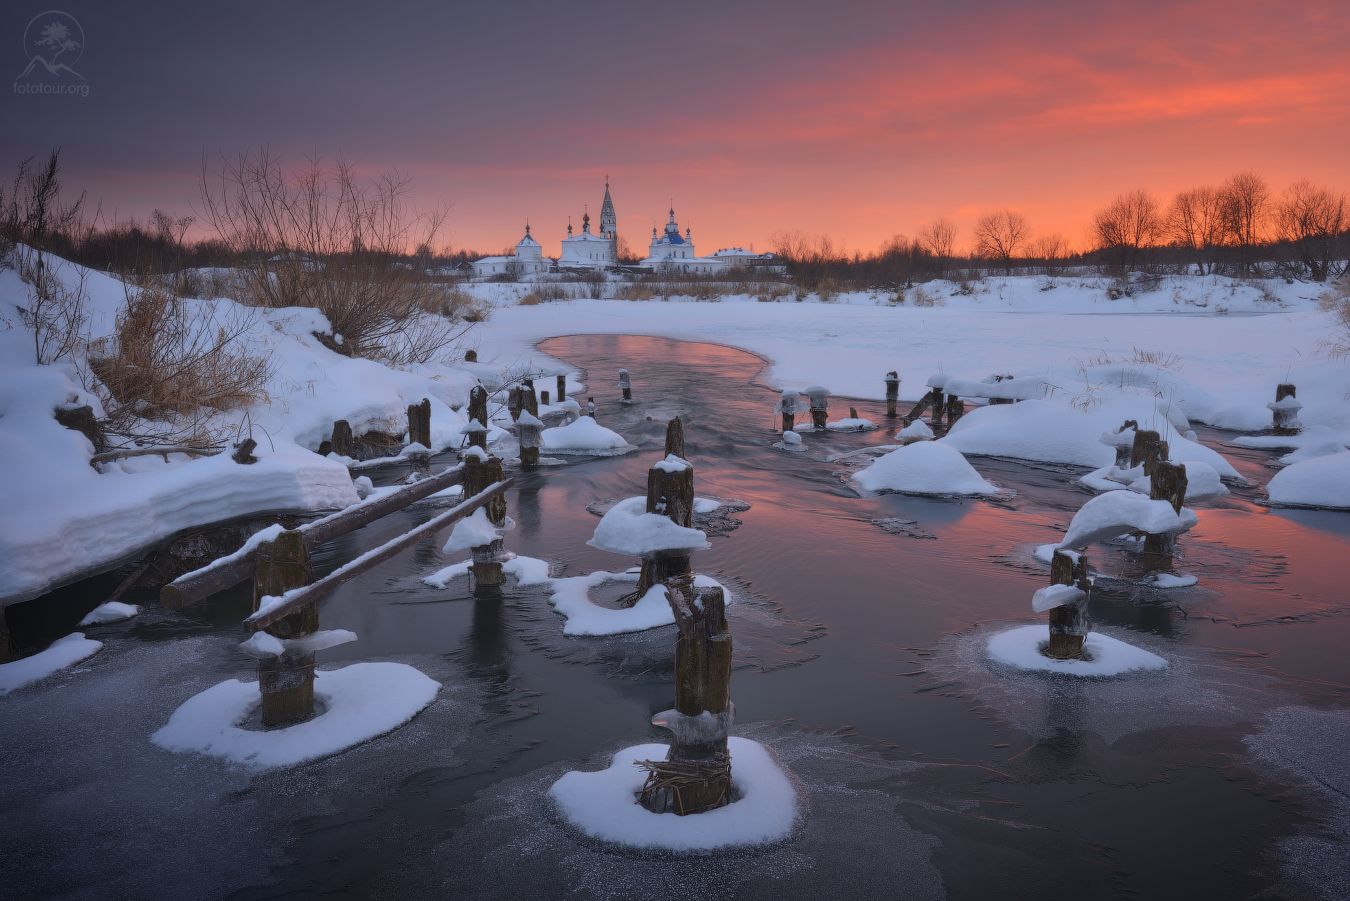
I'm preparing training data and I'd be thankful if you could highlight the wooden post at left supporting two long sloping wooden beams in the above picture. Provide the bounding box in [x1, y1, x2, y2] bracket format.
[254, 530, 319, 728]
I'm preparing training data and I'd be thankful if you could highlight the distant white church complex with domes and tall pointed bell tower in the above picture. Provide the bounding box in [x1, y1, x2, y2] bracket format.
[474, 178, 783, 280]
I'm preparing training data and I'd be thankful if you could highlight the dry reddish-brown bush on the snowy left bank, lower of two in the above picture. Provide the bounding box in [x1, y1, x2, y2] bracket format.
[89, 286, 271, 444]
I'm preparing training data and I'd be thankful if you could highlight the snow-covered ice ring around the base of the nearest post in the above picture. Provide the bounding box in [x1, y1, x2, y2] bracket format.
[548, 736, 798, 854]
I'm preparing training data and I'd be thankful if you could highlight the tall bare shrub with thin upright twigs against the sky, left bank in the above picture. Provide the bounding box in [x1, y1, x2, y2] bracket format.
[201, 149, 468, 362]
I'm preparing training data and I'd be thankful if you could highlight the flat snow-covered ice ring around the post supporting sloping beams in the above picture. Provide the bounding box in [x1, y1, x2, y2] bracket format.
[150, 662, 440, 770]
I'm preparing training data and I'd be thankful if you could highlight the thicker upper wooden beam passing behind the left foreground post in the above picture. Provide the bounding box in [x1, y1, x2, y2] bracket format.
[159, 463, 464, 611]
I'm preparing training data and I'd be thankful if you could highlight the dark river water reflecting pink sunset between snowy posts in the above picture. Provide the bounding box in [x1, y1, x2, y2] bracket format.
[0, 336, 1350, 898]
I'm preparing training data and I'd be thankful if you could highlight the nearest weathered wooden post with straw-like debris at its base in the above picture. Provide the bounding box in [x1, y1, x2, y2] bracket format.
[639, 578, 734, 816]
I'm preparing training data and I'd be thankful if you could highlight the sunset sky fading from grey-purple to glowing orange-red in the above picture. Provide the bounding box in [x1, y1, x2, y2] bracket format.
[0, 0, 1350, 254]
